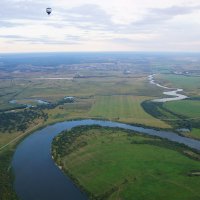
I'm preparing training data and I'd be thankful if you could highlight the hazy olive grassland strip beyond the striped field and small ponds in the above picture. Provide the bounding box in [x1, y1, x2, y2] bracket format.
[0, 77, 162, 109]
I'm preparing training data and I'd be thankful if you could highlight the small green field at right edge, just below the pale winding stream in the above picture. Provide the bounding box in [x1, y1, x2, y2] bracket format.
[164, 100, 200, 118]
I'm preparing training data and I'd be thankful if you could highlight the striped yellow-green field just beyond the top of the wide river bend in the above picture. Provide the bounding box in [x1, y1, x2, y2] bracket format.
[90, 95, 169, 128]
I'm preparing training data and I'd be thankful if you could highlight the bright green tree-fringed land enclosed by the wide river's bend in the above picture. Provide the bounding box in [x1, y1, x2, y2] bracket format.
[52, 127, 200, 200]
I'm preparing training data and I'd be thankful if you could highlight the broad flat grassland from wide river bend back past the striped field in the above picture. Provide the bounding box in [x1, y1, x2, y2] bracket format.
[0, 76, 170, 128]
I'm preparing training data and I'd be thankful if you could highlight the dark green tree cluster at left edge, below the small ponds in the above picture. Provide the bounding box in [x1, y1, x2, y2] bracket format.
[0, 108, 48, 132]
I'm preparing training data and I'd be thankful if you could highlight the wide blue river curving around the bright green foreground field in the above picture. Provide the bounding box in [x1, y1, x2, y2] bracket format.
[12, 120, 200, 200]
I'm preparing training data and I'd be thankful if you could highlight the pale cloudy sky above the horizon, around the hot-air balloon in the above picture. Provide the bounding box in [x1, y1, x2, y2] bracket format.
[0, 0, 200, 53]
